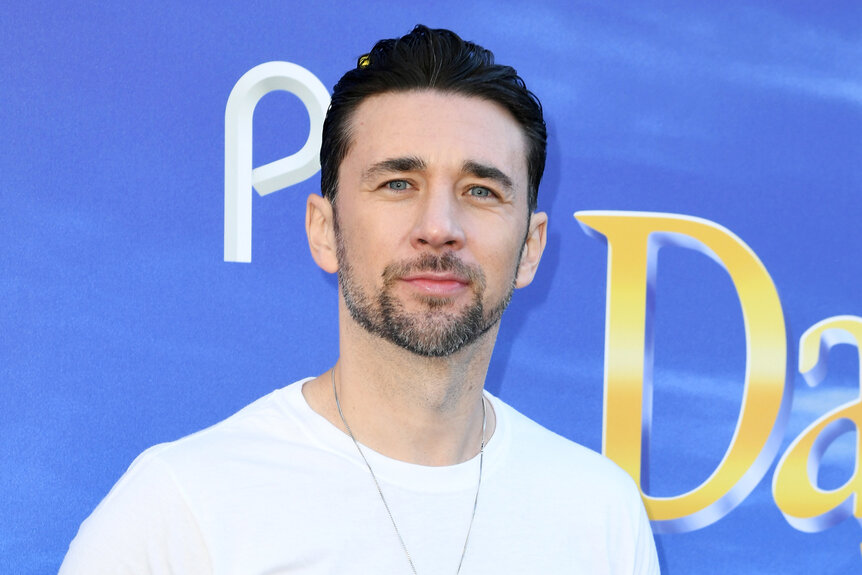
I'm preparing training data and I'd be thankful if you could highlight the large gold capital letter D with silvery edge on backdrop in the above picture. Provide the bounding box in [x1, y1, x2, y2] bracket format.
[575, 211, 790, 533]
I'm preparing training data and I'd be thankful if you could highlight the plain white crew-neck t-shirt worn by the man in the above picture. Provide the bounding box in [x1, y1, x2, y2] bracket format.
[60, 380, 659, 575]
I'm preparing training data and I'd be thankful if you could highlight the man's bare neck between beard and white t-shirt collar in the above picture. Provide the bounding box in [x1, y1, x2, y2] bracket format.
[303, 310, 496, 465]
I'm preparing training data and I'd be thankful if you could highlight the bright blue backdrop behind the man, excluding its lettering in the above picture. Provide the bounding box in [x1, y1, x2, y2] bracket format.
[5, 0, 862, 575]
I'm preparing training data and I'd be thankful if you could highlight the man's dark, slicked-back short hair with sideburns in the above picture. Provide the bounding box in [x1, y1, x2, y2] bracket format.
[320, 25, 547, 213]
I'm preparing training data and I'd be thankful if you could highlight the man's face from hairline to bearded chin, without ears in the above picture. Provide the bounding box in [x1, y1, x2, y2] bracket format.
[335, 91, 540, 357]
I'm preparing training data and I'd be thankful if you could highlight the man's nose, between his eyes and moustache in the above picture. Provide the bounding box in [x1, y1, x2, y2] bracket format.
[411, 186, 464, 250]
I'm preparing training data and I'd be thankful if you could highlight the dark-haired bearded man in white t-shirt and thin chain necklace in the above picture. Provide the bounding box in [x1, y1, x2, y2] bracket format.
[61, 26, 658, 574]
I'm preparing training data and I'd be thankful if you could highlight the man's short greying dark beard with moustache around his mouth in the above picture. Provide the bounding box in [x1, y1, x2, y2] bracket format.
[335, 227, 515, 357]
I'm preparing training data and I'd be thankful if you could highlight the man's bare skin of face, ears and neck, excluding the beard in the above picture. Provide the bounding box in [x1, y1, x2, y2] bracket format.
[303, 90, 547, 465]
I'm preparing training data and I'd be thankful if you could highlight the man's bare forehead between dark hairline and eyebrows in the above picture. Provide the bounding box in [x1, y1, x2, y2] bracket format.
[341, 90, 527, 190]
